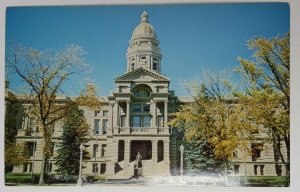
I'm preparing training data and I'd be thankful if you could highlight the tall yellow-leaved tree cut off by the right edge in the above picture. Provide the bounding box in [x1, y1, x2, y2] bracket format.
[236, 33, 290, 185]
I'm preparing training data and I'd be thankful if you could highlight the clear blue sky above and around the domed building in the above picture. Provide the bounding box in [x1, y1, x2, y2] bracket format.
[6, 3, 290, 95]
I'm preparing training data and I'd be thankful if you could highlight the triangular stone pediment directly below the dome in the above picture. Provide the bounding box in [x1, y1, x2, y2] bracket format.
[115, 68, 170, 82]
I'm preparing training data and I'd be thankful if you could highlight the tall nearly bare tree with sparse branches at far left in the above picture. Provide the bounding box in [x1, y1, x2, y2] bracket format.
[6, 45, 86, 184]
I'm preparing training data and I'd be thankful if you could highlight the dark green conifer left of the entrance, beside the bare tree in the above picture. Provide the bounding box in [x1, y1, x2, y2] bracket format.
[55, 106, 90, 176]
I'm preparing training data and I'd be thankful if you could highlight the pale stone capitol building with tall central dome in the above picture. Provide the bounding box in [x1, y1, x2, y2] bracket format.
[5, 11, 285, 179]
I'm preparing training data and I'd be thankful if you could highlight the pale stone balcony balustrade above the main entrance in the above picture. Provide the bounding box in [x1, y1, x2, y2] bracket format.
[113, 127, 171, 135]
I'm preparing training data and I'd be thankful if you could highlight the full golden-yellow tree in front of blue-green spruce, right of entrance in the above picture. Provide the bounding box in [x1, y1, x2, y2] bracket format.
[171, 73, 257, 175]
